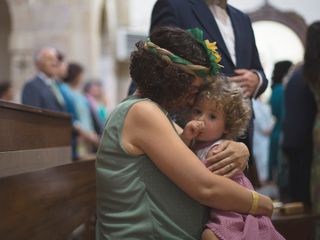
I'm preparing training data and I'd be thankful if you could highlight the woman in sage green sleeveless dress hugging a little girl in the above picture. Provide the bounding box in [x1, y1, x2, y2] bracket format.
[96, 27, 273, 240]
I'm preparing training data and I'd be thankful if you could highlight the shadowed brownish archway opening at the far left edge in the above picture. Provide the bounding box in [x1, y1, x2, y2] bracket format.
[0, 1, 11, 81]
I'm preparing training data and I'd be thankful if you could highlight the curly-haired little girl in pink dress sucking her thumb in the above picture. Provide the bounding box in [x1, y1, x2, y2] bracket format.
[181, 77, 284, 240]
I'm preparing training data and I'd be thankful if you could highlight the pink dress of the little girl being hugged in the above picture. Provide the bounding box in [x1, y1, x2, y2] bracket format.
[196, 142, 285, 240]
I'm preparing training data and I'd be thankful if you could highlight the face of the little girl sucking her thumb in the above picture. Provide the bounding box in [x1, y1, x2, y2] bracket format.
[192, 99, 226, 142]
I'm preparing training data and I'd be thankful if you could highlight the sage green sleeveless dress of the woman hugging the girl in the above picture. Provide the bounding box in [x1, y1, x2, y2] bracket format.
[96, 96, 209, 240]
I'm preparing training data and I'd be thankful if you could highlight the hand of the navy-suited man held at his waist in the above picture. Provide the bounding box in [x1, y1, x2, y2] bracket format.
[228, 69, 260, 97]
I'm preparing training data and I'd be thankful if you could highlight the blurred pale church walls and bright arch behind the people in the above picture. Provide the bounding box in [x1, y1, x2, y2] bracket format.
[0, 0, 320, 110]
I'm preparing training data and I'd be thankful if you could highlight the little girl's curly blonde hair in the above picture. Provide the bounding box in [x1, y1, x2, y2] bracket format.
[196, 75, 252, 139]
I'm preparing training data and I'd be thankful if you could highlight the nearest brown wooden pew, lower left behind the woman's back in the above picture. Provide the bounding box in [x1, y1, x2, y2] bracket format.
[0, 160, 96, 240]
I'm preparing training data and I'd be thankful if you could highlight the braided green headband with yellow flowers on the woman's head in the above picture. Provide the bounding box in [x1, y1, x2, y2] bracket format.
[144, 28, 222, 77]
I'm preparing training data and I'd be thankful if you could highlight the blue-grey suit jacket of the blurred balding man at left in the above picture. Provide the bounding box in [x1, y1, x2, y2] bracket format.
[22, 76, 65, 112]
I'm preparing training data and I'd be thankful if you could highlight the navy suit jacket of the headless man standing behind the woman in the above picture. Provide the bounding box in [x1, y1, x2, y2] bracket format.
[150, 0, 268, 96]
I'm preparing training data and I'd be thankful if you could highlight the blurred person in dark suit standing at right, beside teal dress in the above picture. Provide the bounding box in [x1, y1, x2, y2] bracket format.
[282, 66, 317, 206]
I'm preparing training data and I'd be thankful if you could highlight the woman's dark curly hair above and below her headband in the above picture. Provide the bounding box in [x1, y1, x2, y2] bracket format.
[130, 27, 209, 108]
